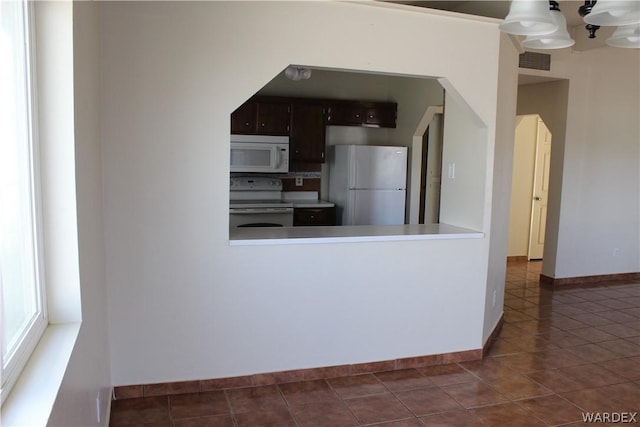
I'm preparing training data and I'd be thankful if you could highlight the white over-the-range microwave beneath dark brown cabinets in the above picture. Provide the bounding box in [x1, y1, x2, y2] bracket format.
[231, 135, 289, 173]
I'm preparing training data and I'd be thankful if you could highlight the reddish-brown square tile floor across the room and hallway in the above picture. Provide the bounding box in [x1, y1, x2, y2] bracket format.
[111, 262, 640, 427]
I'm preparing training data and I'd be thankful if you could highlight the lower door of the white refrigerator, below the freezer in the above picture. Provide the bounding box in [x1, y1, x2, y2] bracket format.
[343, 190, 405, 225]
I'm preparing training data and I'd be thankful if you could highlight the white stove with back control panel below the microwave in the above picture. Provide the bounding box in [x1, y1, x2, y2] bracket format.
[229, 176, 293, 228]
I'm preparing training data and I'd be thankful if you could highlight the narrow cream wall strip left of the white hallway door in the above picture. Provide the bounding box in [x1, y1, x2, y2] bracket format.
[507, 114, 539, 256]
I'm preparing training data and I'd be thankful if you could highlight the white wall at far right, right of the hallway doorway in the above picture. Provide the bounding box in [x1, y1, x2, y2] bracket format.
[518, 48, 640, 278]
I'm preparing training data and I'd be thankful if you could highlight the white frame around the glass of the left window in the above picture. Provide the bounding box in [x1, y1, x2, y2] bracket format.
[0, 0, 49, 403]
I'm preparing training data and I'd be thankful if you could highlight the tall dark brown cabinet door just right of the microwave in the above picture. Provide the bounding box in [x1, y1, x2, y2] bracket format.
[289, 103, 325, 163]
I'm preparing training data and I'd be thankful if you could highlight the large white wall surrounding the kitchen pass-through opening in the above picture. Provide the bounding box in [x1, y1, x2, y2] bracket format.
[99, 2, 510, 385]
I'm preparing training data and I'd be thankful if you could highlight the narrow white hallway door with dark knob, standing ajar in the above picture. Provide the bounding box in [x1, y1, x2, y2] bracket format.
[527, 119, 551, 260]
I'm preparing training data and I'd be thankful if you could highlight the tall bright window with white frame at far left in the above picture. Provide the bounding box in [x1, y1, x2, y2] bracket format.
[0, 1, 47, 401]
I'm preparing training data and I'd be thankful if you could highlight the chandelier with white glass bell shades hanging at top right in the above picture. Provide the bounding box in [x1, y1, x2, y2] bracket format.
[500, 0, 640, 49]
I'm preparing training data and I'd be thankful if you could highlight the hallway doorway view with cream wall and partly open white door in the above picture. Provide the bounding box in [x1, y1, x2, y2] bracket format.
[508, 114, 552, 261]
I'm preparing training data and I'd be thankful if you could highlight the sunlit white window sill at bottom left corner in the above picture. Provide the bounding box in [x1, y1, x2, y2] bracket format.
[1, 322, 80, 426]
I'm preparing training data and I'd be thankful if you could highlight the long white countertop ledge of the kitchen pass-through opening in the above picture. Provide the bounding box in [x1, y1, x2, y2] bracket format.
[229, 224, 484, 246]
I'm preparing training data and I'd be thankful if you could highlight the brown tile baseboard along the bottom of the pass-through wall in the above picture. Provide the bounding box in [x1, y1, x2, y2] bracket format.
[113, 350, 482, 400]
